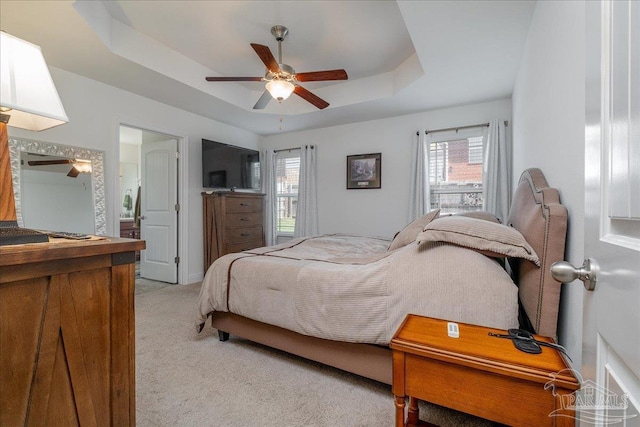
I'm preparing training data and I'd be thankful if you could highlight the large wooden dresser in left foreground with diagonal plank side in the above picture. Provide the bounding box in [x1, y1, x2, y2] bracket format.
[0, 238, 145, 426]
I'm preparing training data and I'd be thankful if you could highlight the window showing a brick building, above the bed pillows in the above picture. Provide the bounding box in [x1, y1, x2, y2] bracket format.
[429, 136, 483, 213]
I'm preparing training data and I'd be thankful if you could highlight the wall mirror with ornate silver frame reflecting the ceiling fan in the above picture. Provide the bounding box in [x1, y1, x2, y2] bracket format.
[9, 138, 107, 235]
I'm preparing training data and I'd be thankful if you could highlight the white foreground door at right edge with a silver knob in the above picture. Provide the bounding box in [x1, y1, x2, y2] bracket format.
[584, 0, 640, 426]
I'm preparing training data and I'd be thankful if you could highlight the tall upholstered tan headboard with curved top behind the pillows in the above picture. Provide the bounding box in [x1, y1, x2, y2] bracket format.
[507, 169, 567, 338]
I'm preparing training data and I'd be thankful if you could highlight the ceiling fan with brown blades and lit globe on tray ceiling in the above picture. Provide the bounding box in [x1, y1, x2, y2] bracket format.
[206, 25, 348, 110]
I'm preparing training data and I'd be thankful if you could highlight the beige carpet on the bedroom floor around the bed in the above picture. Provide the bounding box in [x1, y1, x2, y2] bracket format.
[136, 284, 500, 427]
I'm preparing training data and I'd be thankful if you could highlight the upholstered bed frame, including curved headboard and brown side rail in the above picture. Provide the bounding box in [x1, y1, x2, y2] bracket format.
[211, 169, 567, 384]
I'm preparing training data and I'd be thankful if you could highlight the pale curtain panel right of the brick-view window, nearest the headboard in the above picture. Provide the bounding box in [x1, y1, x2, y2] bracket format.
[482, 119, 511, 223]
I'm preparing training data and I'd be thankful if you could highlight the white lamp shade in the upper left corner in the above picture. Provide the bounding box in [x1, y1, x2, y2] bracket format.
[0, 32, 69, 131]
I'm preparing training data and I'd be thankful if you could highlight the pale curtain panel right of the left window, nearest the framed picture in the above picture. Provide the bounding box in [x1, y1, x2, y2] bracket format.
[293, 145, 318, 237]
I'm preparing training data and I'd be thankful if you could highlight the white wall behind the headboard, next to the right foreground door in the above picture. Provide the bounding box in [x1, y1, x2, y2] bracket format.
[512, 1, 585, 369]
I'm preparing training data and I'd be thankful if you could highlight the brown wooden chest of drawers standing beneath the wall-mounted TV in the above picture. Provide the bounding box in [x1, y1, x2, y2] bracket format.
[202, 192, 264, 272]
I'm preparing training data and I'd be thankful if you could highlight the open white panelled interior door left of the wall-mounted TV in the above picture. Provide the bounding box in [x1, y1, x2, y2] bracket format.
[140, 139, 179, 283]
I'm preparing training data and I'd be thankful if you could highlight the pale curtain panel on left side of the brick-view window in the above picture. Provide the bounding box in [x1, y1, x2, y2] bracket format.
[407, 131, 430, 223]
